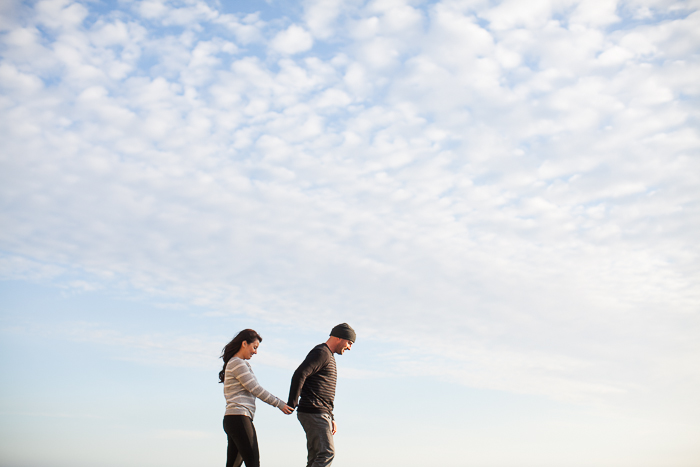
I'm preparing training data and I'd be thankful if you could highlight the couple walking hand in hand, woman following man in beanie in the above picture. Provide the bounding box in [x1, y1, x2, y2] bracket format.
[219, 323, 356, 467]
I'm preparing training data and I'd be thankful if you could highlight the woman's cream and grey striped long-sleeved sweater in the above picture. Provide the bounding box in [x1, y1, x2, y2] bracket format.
[224, 357, 284, 420]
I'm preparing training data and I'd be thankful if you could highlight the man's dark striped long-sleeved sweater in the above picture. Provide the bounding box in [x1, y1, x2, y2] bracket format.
[287, 344, 338, 417]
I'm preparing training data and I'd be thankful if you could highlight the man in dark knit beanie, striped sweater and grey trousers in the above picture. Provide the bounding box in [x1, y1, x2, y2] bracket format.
[287, 323, 356, 467]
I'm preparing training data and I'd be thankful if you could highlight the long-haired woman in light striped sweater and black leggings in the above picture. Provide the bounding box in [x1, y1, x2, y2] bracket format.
[219, 329, 294, 467]
